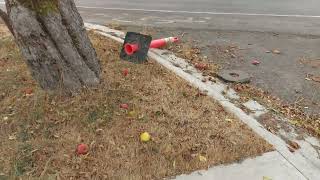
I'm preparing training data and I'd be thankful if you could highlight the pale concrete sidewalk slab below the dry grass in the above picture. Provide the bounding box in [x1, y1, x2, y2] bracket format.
[176, 151, 307, 180]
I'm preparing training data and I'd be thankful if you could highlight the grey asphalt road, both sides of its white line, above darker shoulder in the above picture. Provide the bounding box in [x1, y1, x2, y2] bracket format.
[76, 0, 320, 35]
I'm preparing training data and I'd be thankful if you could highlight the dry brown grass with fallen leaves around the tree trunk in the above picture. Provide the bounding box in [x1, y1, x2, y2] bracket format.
[0, 26, 273, 179]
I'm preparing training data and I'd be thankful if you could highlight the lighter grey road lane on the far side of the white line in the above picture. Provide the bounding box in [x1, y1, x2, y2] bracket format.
[76, 0, 320, 16]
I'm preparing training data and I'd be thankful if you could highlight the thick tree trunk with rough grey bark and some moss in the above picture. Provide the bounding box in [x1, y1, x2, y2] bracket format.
[1, 0, 101, 91]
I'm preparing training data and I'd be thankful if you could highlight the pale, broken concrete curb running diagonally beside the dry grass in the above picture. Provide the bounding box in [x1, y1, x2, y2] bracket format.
[85, 23, 320, 180]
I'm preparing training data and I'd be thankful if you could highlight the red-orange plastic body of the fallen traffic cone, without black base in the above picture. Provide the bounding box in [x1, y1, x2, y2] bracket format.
[124, 37, 179, 55]
